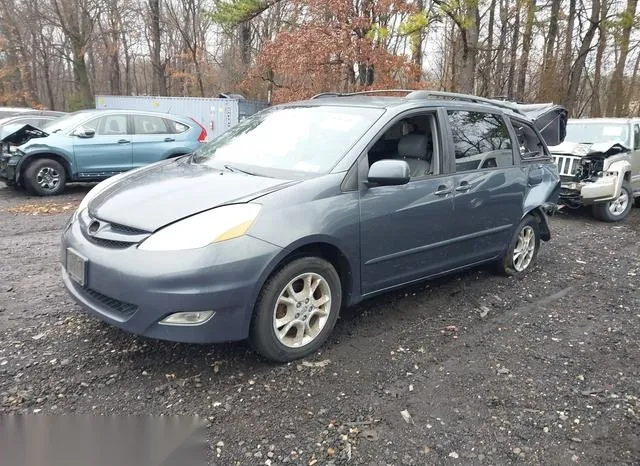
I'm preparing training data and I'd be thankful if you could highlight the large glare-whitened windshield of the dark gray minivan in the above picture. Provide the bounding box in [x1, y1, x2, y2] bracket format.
[193, 106, 384, 174]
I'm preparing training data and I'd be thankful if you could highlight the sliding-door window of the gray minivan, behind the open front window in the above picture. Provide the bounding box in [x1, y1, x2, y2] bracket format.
[448, 110, 513, 172]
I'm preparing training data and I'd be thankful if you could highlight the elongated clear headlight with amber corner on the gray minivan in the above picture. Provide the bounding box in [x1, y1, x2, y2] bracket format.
[138, 204, 261, 251]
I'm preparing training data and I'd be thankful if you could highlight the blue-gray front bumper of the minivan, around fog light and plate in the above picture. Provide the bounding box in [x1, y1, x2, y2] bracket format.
[62, 217, 282, 343]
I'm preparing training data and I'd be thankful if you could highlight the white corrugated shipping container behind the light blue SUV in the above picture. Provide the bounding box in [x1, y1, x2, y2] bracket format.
[96, 95, 268, 140]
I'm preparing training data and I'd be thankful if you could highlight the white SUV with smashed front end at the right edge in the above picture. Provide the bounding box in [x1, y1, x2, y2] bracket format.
[549, 118, 640, 222]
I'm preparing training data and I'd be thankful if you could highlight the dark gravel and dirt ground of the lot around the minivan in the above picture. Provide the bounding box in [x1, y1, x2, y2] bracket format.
[0, 183, 640, 465]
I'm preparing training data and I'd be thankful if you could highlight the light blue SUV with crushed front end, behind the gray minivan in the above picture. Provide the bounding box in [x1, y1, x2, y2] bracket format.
[0, 110, 207, 196]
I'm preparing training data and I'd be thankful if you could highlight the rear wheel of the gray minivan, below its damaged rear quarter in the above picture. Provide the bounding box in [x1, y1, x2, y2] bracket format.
[496, 215, 540, 277]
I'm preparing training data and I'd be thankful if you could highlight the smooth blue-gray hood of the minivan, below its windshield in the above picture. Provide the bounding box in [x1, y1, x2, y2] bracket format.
[89, 157, 297, 232]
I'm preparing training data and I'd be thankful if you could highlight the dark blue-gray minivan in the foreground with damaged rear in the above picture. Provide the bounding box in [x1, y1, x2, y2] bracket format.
[62, 91, 566, 361]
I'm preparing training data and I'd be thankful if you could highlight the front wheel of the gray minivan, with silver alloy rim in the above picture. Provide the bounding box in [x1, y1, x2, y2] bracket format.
[249, 257, 342, 362]
